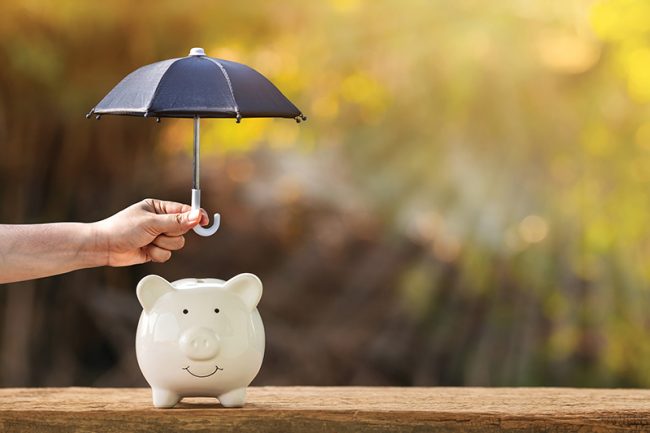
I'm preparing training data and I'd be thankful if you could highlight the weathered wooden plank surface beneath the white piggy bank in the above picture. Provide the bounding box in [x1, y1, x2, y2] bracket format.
[0, 387, 650, 433]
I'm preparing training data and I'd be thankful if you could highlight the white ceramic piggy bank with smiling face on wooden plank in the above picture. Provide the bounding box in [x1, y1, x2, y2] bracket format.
[135, 274, 264, 408]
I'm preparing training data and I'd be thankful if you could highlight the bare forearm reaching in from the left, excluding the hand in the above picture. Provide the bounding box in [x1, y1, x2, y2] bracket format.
[0, 223, 108, 283]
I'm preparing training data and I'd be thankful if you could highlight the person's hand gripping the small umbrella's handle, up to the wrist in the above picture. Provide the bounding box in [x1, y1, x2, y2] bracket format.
[93, 199, 209, 266]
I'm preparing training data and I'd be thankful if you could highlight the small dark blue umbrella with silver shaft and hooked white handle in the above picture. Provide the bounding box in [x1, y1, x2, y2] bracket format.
[86, 48, 307, 236]
